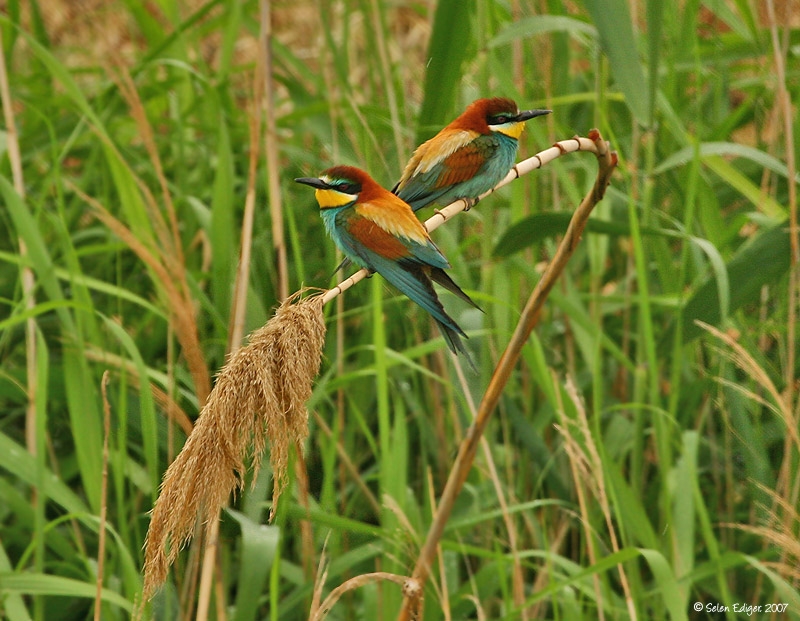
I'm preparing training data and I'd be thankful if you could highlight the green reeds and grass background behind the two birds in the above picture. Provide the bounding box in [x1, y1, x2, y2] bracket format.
[0, 0, 800, 621]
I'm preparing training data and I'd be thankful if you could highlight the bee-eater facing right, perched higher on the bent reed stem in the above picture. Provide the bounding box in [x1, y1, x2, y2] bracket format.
[392, 97, 552, 211]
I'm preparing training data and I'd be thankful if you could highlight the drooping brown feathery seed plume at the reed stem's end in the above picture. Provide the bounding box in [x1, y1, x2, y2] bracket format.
[144, 291, 325, 600]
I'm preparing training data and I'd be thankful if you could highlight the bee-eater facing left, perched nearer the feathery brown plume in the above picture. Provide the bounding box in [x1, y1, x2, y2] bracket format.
[295, 166, 478, 365]
